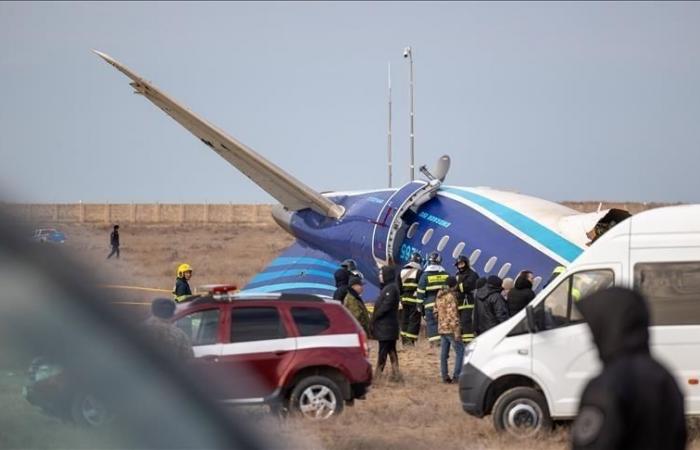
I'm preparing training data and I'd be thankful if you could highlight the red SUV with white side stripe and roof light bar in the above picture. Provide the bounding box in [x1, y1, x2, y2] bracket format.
[172, 289, 372, 419]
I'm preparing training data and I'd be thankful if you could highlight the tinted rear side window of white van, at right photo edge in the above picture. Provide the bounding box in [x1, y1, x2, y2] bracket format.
[634, 262, 700, 325]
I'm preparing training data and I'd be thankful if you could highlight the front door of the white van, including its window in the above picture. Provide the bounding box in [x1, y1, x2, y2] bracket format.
[532, 265, 621, 417]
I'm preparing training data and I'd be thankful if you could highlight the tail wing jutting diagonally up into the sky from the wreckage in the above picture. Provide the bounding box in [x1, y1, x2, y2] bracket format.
[94, 50, 344, 219]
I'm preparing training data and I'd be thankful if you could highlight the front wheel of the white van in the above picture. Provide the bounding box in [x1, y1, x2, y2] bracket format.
[493, 387, 552, 437]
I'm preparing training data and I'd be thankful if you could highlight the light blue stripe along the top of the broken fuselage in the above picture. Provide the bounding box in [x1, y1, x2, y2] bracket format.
[442, 188, 583, 262]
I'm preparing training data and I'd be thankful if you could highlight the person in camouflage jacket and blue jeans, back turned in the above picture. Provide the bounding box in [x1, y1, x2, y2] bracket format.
[434, 277, 464, 383]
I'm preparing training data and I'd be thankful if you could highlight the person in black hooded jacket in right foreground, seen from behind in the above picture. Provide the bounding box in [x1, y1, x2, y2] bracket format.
[571, 288, 686, 450]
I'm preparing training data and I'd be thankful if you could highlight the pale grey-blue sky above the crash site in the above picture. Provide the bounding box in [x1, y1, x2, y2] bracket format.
[0, 2, 700, 203]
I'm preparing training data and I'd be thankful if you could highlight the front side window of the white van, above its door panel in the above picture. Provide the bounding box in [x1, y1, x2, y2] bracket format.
[535, 269, 615, 330]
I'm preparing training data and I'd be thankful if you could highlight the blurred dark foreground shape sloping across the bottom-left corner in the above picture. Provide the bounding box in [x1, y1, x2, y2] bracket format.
[0, 211, 270, 449]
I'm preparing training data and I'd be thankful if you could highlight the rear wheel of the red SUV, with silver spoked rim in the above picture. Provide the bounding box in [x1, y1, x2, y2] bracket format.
[289, 376, 343, 420]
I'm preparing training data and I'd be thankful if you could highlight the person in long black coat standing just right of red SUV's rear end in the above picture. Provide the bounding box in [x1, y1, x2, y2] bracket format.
[370, 266, 401, 381]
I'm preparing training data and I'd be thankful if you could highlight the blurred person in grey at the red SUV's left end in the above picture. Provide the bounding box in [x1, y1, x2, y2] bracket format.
[144, 298, 194, 360]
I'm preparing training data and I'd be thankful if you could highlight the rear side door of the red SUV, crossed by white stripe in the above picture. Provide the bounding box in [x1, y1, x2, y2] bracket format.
[220, 305, 296, 402]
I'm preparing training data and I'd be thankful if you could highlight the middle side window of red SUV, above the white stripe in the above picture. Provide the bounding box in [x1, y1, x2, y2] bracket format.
[231, 307, 287, 342]
